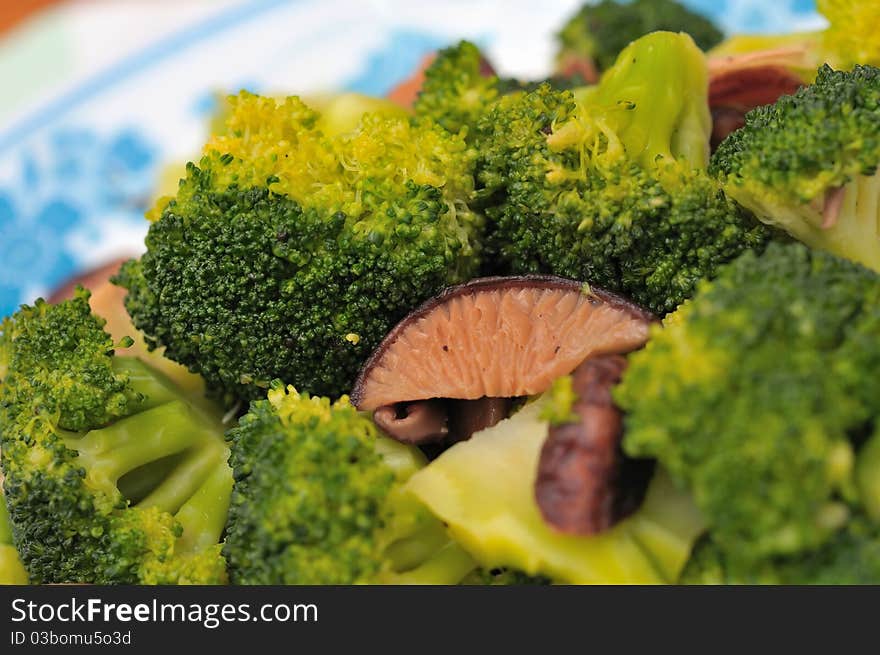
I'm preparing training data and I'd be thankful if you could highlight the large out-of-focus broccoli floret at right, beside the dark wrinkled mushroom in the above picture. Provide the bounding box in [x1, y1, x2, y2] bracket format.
[615, 243, 880, 570]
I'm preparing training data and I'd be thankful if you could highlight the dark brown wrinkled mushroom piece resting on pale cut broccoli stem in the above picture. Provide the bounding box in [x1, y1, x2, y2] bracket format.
[535, 355, 653, 535]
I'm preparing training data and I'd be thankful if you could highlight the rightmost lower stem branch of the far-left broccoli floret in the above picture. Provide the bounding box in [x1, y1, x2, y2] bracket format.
[175, 458, 232, 553]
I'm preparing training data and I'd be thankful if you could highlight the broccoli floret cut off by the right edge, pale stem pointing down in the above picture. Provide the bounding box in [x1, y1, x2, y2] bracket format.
[710, 66, 880, 270]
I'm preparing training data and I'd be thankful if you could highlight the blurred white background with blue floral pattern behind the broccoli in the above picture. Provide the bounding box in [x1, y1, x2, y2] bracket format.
[0, 0, 823, 316]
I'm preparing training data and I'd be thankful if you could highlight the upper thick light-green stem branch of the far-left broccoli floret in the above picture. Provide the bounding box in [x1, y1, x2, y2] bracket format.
[65, 401, 205, 502]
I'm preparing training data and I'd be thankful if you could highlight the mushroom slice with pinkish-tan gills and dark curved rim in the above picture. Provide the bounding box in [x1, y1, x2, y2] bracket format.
[351, 276, 654, 410]
